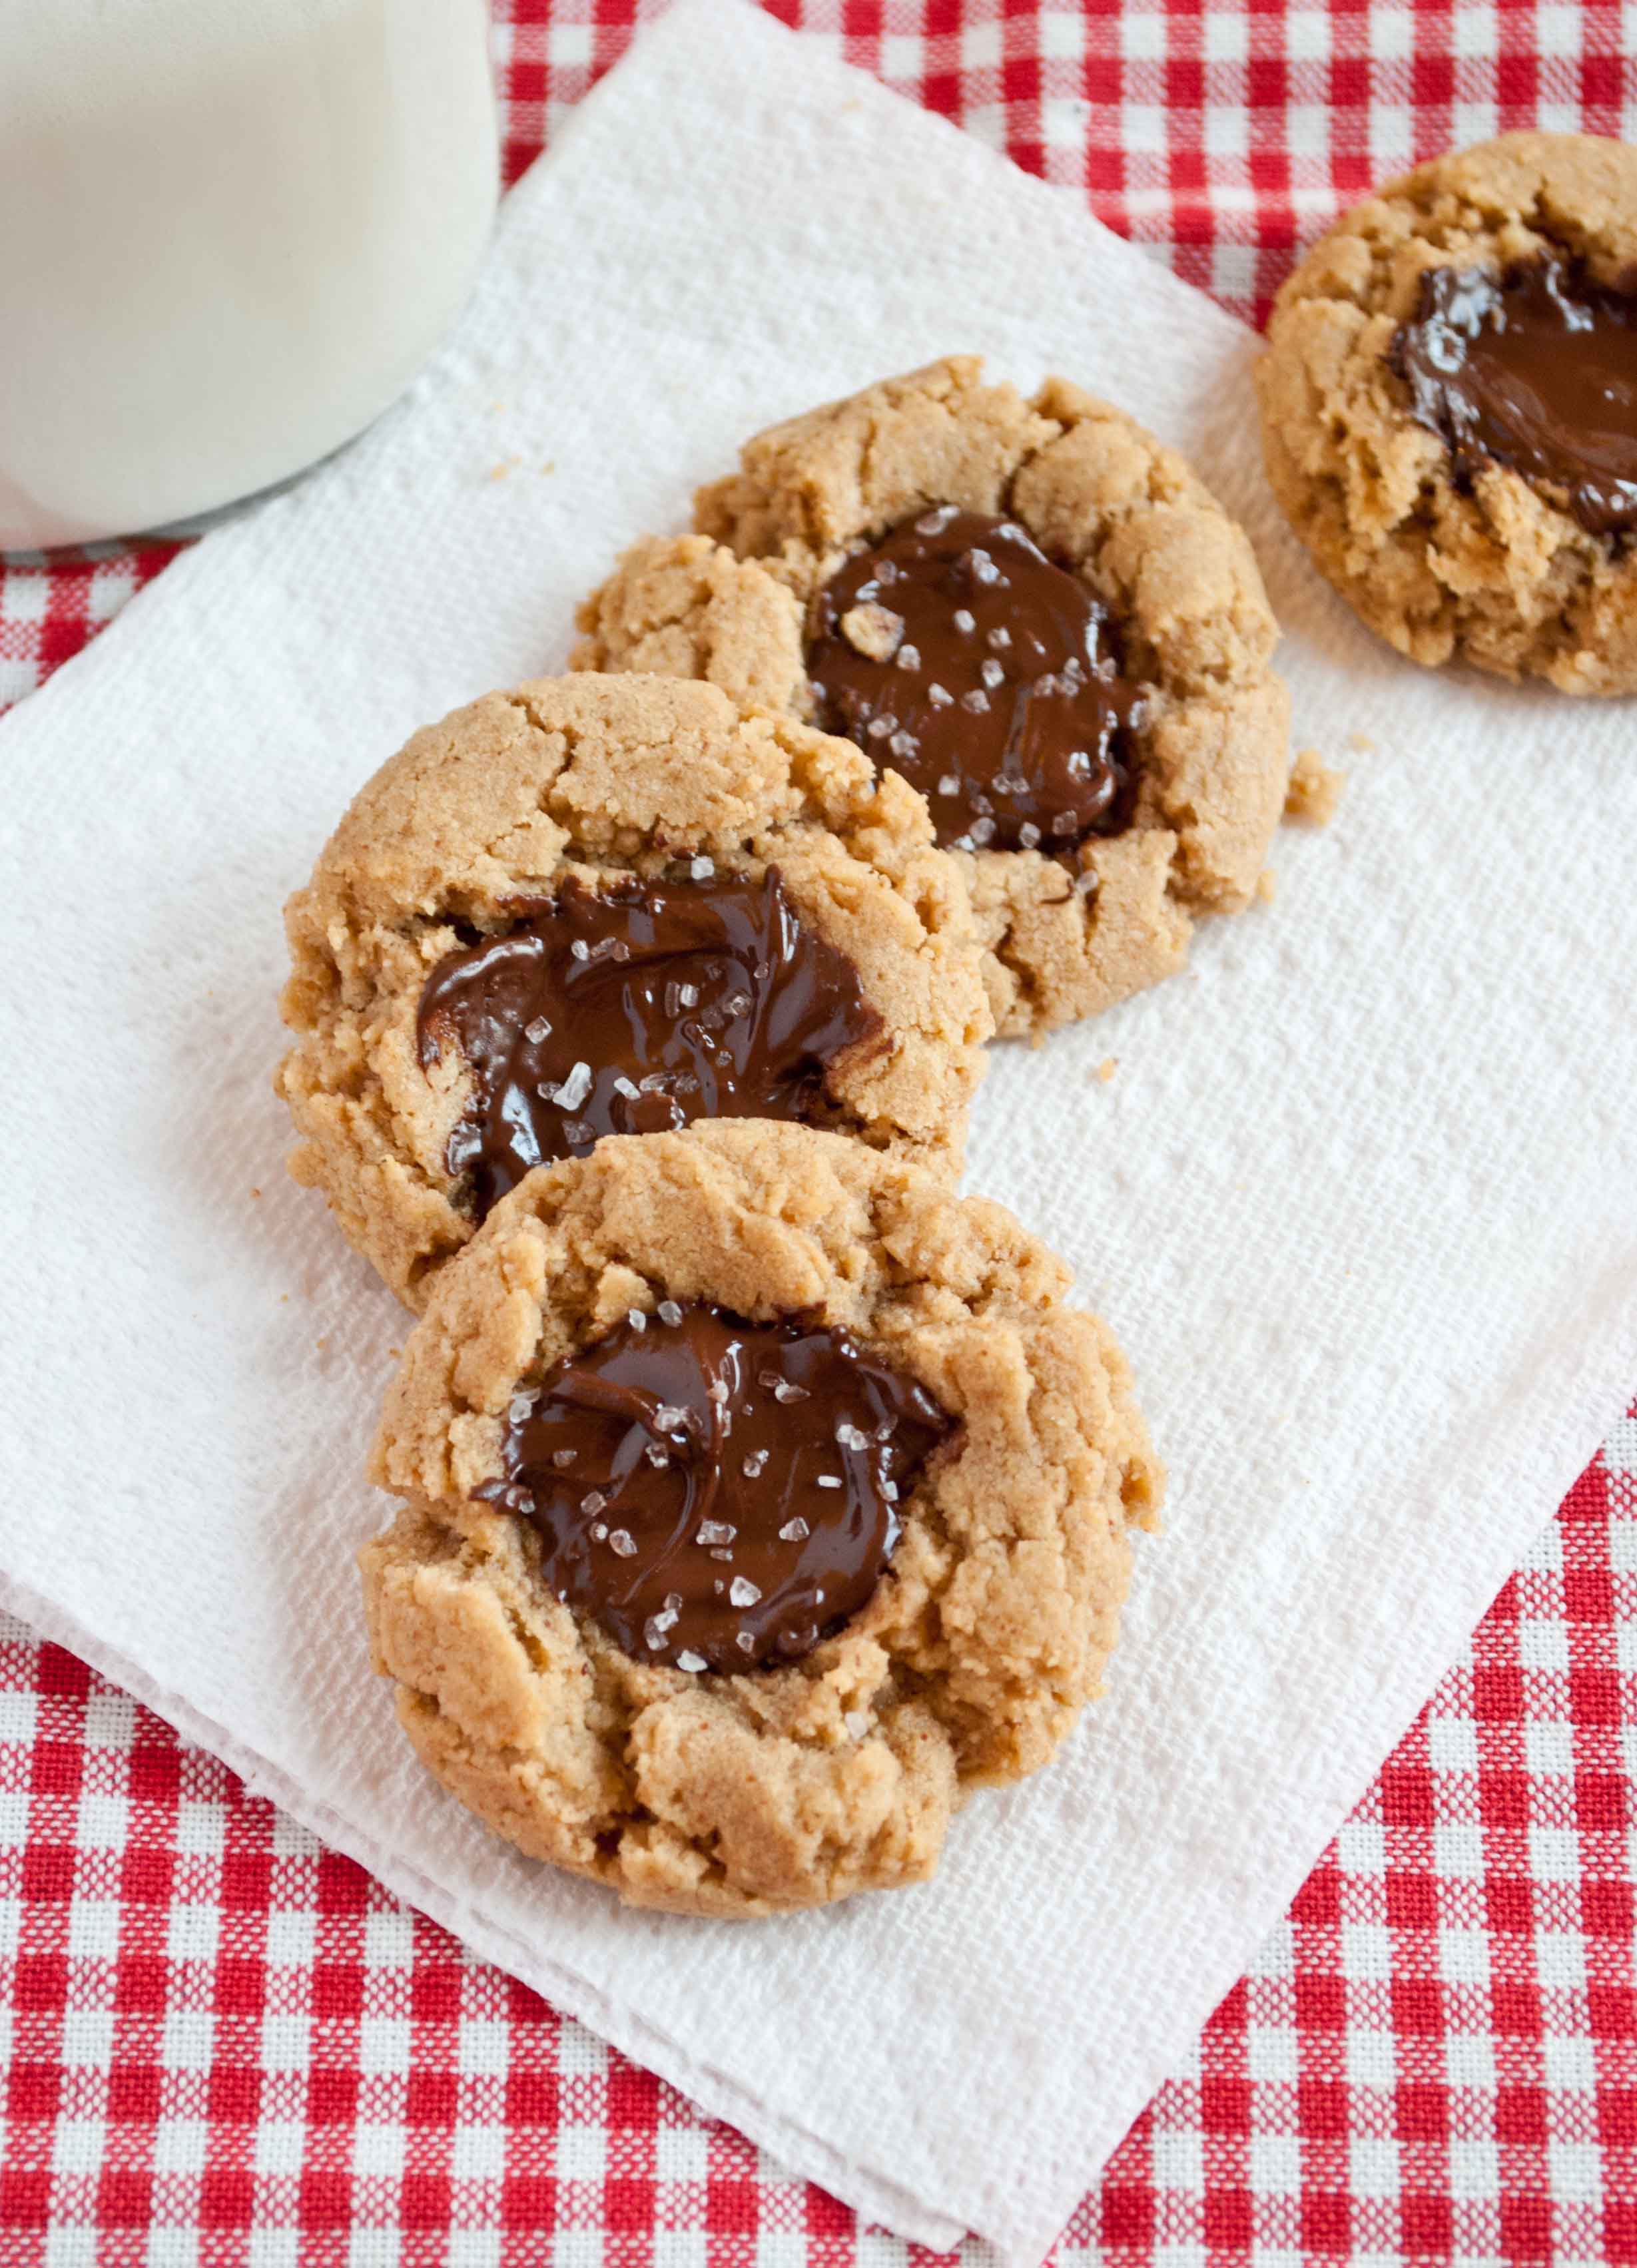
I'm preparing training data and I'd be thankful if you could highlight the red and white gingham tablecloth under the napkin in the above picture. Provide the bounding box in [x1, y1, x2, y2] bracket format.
[0, 0, 1637, 2268]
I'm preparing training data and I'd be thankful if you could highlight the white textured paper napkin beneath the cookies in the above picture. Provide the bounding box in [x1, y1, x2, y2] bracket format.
[0, 0, 1637, 2263]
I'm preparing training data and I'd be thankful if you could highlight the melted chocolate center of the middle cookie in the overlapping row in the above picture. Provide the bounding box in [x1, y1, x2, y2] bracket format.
[417, 860, 880, 1220]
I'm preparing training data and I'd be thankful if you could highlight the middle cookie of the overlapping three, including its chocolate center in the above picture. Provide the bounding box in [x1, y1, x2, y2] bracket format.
[276, 676, 988, 1306]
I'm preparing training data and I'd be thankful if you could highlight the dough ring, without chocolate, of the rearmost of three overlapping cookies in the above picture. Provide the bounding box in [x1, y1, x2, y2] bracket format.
[573, 356, 1288, 1034]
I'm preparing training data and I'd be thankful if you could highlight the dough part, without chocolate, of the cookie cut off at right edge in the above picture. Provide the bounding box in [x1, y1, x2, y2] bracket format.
[1258, 134, 1637, 694]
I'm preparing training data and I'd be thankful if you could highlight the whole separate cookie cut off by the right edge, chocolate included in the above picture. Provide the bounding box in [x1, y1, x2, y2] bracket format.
[1258, 134, 1637, 694]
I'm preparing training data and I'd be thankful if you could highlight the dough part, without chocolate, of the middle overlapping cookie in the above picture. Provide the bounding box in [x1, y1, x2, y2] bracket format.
[276, 676, 988, 1306]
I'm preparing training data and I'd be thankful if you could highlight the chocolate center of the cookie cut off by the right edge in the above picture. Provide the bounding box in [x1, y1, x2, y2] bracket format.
[1388, 258, 1637, 535]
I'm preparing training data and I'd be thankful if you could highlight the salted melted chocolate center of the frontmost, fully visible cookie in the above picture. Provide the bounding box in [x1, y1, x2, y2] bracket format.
[478, 1300, 952, 1669]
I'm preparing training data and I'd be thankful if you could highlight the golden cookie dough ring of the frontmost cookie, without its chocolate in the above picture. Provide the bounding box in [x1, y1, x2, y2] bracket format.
[360, 1121, 1163, 1914]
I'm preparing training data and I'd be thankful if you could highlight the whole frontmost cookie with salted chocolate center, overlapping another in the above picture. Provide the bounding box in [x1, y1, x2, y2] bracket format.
[360, 1121, 1163, 1916]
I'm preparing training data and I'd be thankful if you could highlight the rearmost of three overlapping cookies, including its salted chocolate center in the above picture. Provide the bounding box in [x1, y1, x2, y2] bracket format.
[573, 356, 1288, 1034]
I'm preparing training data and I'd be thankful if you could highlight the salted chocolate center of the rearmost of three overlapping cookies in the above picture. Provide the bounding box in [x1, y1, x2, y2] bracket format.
[807, 503, 1143, 850]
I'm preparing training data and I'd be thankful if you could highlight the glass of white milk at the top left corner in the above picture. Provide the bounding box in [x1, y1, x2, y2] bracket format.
[0, 0, 499, 549]
